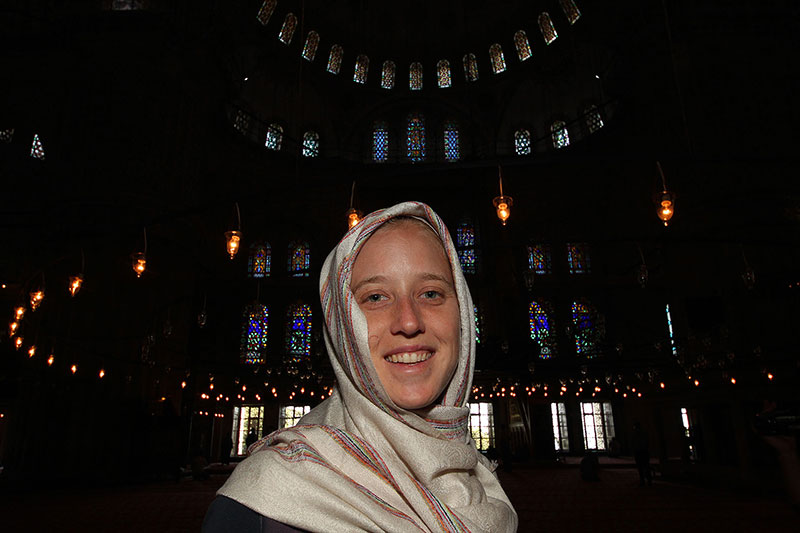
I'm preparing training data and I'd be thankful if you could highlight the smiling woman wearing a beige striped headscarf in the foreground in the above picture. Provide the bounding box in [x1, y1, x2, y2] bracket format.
[204, 202, 517, 532]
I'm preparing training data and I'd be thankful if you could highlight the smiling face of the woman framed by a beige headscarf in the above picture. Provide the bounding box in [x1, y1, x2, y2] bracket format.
[350, 221, 461, 409]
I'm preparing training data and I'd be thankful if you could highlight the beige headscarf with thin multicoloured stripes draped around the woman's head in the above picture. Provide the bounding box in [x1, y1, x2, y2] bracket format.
[218, 202, 517, 533]
